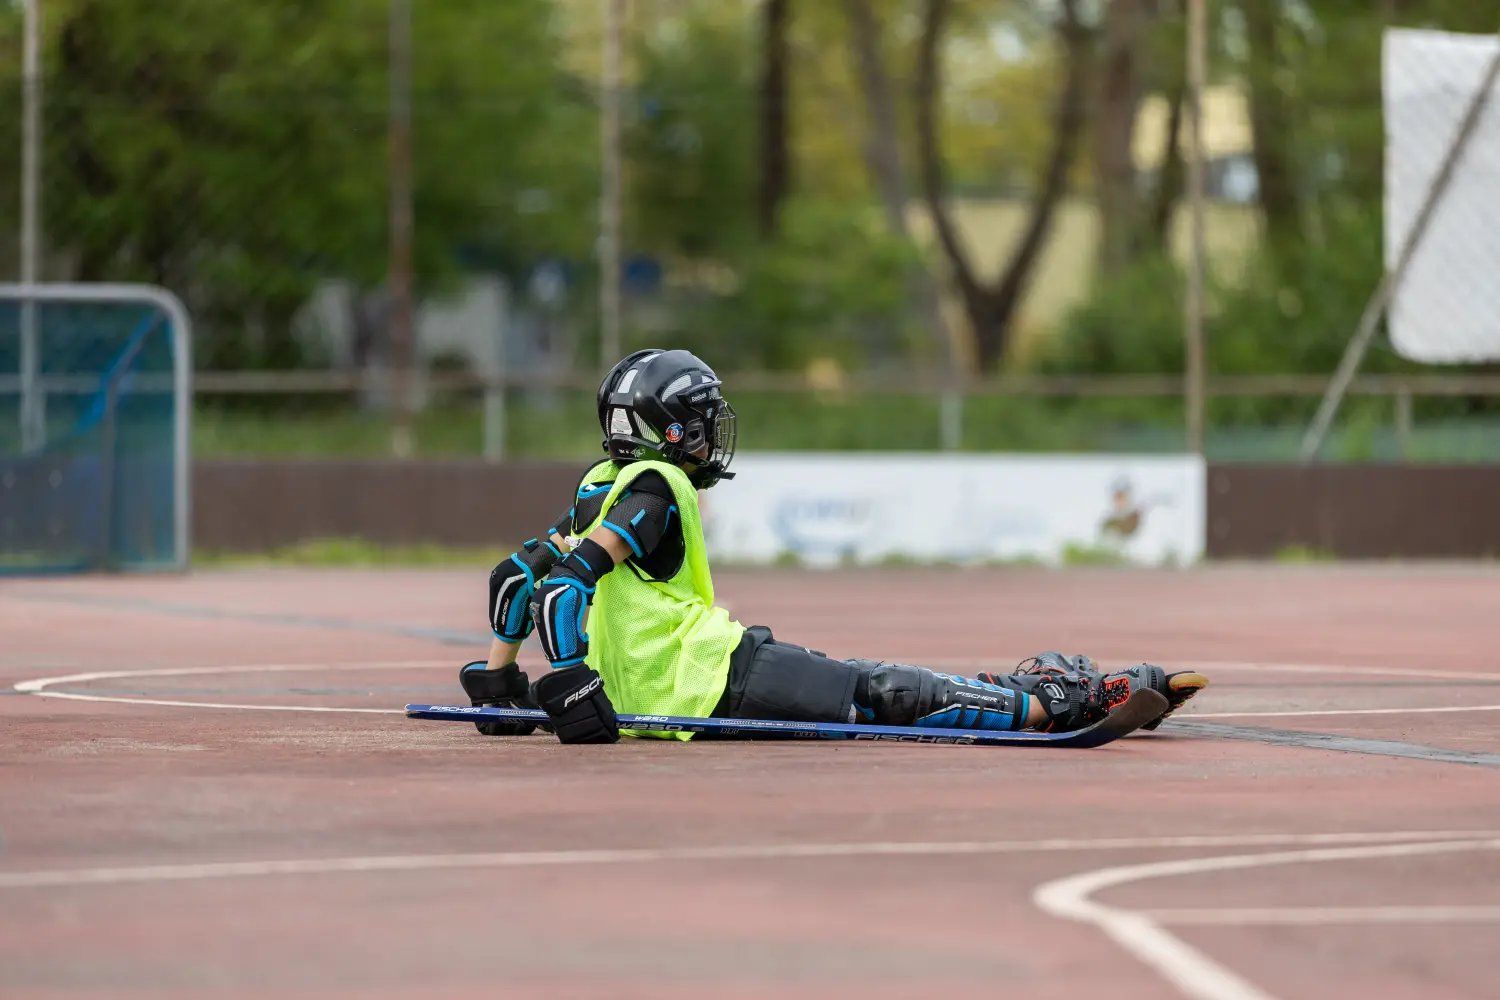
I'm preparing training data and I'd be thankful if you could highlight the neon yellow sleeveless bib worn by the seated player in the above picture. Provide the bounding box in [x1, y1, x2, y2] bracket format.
[575, 462, 746, 739]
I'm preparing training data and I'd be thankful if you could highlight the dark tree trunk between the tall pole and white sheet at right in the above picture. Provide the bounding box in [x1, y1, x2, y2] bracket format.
[1241, 0, 1299, 243]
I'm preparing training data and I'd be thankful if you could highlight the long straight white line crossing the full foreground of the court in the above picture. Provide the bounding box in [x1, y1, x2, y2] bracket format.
[0, 831, 1500, 889]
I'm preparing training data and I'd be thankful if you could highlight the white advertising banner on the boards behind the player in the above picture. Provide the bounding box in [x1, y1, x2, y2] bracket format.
[702, 453, 1206, 565]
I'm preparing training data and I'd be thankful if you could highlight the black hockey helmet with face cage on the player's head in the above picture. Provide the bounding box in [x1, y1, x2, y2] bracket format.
[597, 351, 737, 490]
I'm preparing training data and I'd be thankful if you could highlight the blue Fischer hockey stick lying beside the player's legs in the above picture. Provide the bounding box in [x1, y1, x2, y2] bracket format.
[407, 691, 1167, 748]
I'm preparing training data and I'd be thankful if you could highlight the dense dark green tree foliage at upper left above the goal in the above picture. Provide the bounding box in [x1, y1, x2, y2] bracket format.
[0, 0, 596, 367]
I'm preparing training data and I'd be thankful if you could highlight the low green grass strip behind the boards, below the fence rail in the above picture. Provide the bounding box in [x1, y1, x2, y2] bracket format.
[190, 387, 1500, 463]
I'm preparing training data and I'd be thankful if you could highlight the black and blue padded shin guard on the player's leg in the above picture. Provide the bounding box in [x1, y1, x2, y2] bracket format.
[854, 661, 1031, 732]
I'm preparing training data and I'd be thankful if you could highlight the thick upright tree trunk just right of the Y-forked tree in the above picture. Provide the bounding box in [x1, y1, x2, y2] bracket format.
[1094, 0, 1157, 276]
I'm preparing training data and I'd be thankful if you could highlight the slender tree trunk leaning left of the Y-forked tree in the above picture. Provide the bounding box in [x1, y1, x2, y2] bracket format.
[846, 0, 959, 375]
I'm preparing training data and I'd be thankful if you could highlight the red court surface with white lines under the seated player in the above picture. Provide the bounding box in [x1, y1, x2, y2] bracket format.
[0, 567, 1500, 1000]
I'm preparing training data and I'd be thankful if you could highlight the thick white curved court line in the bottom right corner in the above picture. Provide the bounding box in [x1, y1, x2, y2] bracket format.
[1032, 840, 1500, 1000]
